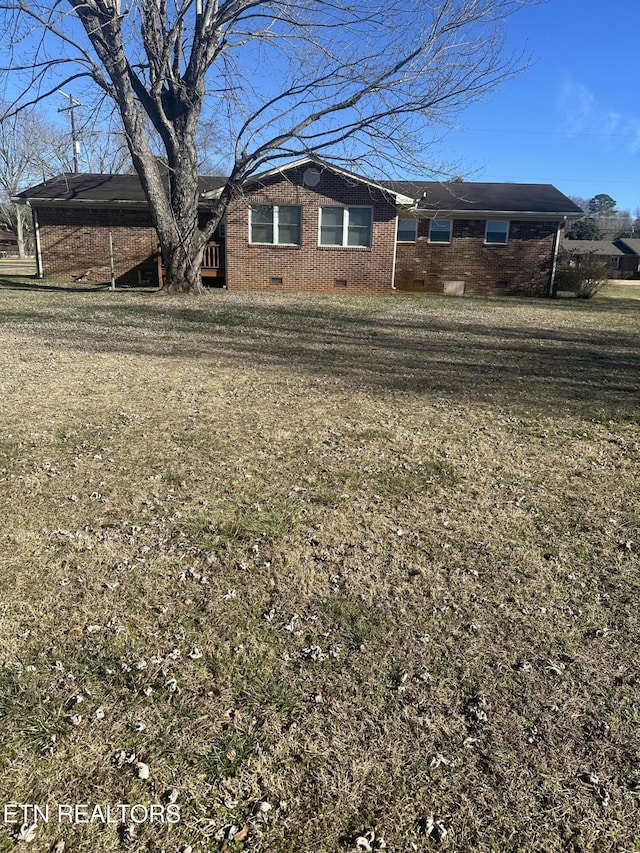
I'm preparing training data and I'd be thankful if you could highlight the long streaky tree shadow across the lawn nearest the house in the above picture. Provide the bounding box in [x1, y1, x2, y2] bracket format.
[1, 298, 640, 422]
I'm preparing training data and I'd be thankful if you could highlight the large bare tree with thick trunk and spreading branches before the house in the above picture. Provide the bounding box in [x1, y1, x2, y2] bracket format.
[0, 0, 538, 293]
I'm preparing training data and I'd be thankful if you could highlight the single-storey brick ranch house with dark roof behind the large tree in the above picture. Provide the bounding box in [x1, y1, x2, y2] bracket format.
[17, 157, 584, 296]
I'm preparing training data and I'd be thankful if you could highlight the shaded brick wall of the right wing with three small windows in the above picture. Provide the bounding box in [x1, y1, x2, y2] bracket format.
[396, 219, 557, 296]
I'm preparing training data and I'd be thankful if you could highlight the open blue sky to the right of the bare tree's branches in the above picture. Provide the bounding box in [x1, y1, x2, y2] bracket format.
[441, 0, 640, 213]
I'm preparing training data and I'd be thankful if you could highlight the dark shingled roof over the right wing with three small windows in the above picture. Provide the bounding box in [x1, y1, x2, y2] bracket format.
[381, 181, 584, 217]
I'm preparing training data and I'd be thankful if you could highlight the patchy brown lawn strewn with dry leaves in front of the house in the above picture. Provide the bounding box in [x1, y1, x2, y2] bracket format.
[0, 285, 640, 853]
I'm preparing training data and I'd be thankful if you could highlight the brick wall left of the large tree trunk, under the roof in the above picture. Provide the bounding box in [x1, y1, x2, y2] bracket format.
[38, 206, 158, 285]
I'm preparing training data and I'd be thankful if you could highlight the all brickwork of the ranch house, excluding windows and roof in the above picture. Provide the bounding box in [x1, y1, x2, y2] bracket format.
[33, 175, 556, 295]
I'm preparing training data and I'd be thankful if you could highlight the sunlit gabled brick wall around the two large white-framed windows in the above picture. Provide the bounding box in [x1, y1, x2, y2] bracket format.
[226, 168, 396, 295]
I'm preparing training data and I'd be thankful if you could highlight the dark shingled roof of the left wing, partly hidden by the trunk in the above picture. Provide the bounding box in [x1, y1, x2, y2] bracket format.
[16, 174, 226, 204]
